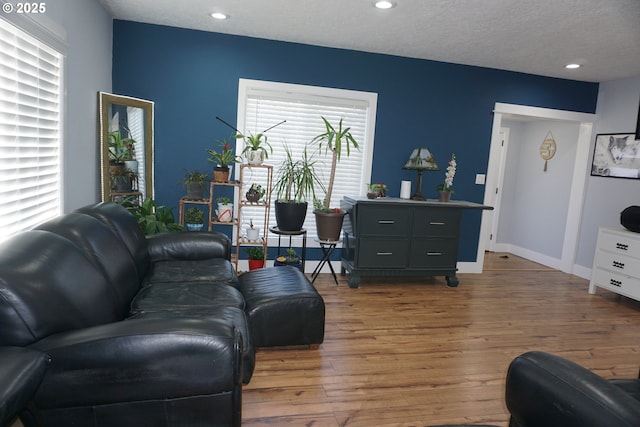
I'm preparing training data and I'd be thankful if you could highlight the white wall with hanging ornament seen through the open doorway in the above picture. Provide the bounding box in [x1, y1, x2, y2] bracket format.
[496, 120, 579, 260]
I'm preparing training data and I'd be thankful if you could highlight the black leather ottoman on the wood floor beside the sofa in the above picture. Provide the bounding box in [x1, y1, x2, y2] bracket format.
[238, 267, 325, 348]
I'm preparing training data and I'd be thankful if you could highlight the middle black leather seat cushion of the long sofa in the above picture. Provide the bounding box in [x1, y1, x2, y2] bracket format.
[131, 282, 244, 315]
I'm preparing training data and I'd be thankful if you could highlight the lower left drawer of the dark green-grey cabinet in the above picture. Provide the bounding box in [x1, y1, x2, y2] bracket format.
[357, 238, 408, 268]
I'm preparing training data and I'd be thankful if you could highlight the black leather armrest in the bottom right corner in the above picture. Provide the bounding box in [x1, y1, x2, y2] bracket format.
[506, 351, 640, 427]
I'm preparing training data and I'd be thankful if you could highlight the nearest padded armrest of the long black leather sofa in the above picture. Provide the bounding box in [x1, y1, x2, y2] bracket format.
[31, 317, 243, 409]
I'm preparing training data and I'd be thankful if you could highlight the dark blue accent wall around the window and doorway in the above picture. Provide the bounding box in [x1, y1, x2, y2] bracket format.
[113, 20, 598, 262]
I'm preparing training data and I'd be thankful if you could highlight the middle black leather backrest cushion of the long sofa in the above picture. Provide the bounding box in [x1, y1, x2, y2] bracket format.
[37, 213, 140, 318]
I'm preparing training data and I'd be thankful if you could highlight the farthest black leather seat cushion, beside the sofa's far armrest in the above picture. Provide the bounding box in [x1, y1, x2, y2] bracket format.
[143, 258, 238, 287]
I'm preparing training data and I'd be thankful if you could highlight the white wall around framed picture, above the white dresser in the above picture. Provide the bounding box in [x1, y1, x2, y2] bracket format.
[576, 76, 640, 271]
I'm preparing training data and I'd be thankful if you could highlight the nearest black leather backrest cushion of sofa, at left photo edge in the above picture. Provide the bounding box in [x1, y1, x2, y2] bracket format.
[0, 230, 119, 346]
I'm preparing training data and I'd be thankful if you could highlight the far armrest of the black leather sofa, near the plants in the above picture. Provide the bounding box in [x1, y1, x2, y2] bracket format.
[147, 231, 231, 262]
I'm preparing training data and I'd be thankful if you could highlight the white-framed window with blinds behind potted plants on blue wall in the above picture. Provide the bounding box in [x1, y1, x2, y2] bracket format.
[237, 79, 377, 242]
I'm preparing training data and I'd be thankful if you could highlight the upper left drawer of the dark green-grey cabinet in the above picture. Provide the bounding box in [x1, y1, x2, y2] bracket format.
[358, 206, 411, 237]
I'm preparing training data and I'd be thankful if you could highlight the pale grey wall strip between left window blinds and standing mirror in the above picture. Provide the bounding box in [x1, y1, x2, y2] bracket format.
[46, 0, 113, 213]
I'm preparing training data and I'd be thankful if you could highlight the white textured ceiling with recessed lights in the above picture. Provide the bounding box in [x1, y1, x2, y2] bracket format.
[99, 0, 640, 82]
